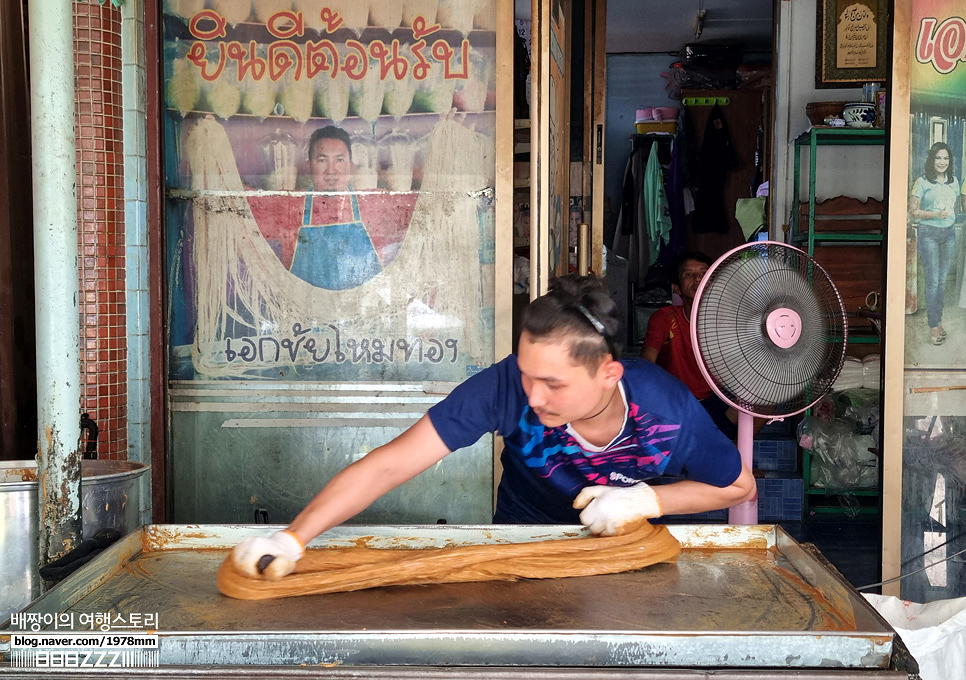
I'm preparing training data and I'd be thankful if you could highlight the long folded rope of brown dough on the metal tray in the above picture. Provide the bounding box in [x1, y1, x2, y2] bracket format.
[216, 523, 681, 600]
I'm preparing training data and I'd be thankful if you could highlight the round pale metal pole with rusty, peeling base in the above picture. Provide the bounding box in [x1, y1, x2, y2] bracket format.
[27, 0, 81, 564]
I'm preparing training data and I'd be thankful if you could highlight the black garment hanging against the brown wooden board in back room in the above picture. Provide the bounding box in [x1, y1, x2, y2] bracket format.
[691, 104, 738, 234]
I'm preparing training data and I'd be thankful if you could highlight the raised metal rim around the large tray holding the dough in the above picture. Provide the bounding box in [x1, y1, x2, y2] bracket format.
[0, 525, 894, 669]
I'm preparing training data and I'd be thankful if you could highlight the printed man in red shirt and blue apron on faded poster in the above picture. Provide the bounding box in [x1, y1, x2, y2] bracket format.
[249, 125, 415, 290]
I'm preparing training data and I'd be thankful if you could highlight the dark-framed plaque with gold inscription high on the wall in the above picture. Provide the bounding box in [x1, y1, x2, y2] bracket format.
[815, 0, 889, 88]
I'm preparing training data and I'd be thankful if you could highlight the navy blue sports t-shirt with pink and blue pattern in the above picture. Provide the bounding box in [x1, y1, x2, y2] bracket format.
[429, 355, 741, 524]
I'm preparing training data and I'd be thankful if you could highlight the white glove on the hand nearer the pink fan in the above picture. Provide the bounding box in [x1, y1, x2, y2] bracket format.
[574, 482, 663, 536]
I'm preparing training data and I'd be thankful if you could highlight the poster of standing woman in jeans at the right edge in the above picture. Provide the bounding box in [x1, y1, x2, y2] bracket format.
[905, 0, 966, 369]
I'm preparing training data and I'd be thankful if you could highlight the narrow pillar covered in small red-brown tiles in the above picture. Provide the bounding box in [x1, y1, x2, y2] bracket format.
[73, 0, 128, 460]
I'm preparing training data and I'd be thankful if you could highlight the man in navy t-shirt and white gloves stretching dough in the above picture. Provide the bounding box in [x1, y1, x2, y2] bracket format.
[232, 276, 756, 579]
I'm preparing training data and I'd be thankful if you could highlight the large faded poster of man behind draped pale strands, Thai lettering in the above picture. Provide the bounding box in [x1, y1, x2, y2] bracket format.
[163, 0, 496, 381]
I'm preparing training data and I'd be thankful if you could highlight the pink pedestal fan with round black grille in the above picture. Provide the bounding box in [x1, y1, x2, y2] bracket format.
[691, 241, 848, 524]
